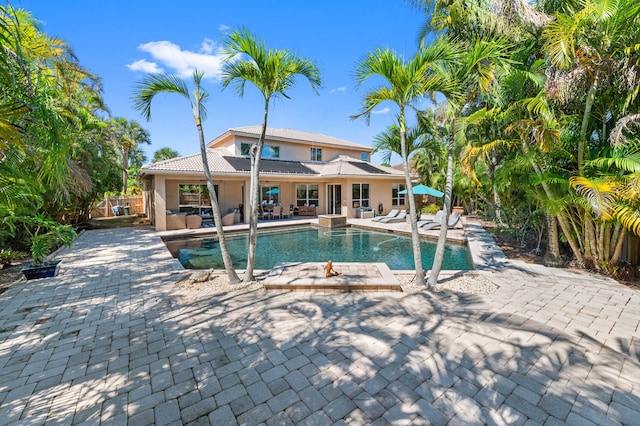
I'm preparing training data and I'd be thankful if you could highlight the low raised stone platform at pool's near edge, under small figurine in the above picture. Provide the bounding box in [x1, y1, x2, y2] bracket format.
[263, 262, 402, 292]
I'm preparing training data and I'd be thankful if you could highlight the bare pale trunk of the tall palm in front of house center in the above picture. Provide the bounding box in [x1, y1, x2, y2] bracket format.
[243, 99, 269, 283]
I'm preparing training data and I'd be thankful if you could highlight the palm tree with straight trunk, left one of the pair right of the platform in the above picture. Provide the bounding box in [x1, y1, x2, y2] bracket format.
[352, 45, 452, 285]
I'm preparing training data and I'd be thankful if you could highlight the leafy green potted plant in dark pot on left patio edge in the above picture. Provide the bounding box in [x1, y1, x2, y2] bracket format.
[19, 214, 76, 280]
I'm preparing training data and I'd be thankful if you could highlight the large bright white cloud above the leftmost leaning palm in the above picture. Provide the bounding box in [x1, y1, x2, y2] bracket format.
[127, 38, 222, 80]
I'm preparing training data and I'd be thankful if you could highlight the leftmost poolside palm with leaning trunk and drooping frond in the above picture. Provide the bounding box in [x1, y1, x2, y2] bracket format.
[133, 70, 240, 284]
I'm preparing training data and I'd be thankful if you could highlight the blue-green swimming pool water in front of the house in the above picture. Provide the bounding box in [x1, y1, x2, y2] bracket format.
[165, 227, 473, 270]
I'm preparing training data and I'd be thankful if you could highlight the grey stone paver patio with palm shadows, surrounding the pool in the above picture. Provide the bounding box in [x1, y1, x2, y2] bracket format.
[0, 225, 640, 425]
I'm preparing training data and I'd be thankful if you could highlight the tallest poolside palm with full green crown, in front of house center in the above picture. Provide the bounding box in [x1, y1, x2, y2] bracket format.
[222, 29, 321, 282]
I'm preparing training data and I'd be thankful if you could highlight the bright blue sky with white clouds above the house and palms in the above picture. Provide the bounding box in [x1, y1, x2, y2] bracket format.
[16, 0, 424, 164]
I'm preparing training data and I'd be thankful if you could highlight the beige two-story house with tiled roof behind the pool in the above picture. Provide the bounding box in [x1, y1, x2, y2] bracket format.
[139, 126, 407, 230]
